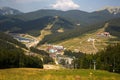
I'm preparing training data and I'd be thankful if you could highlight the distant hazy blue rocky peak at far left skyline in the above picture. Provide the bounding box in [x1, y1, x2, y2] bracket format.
[0, 7, 22, 15]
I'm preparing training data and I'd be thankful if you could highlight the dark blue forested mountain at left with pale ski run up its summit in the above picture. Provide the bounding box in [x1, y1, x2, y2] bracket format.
[0, 16, 75, 36]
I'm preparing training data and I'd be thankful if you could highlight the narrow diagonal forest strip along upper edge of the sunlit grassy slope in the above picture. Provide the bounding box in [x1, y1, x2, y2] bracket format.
[39, 23, 104, 44]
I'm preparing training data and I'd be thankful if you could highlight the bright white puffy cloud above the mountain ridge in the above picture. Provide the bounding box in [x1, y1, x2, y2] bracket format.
[52, 0, 80, 10]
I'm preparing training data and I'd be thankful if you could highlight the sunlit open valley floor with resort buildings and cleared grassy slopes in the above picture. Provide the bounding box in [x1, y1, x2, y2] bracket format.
[8, 22, 119, 69]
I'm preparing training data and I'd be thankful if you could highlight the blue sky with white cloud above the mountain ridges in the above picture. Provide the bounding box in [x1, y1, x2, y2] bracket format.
[0, 0, 120, 12]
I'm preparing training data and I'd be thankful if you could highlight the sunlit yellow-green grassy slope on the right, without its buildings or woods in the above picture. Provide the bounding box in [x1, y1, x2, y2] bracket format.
[57, 23, 118, 53]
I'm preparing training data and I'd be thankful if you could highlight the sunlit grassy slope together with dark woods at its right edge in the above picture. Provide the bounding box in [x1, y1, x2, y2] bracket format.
[56, 19, 120, 53]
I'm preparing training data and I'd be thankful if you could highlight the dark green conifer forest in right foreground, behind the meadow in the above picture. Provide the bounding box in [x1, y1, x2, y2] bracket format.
[65, 43, 120, 73]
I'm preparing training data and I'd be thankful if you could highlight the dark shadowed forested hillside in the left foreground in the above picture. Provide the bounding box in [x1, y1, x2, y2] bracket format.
[0, 32, 43, 68]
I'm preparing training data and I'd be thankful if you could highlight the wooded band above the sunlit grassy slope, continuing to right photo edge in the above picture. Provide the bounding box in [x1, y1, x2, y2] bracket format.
[40, 18, 120, 44]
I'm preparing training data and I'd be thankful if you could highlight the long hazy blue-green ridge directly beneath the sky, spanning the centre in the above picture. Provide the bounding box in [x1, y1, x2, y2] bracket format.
[13, 8, 120, 26]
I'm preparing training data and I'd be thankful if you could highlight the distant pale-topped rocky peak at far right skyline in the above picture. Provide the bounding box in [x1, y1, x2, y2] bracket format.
[91, 7, 120, 21]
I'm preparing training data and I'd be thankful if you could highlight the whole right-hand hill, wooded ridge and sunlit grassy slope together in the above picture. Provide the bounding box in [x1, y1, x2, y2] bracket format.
[37, 18, 120, 53]
